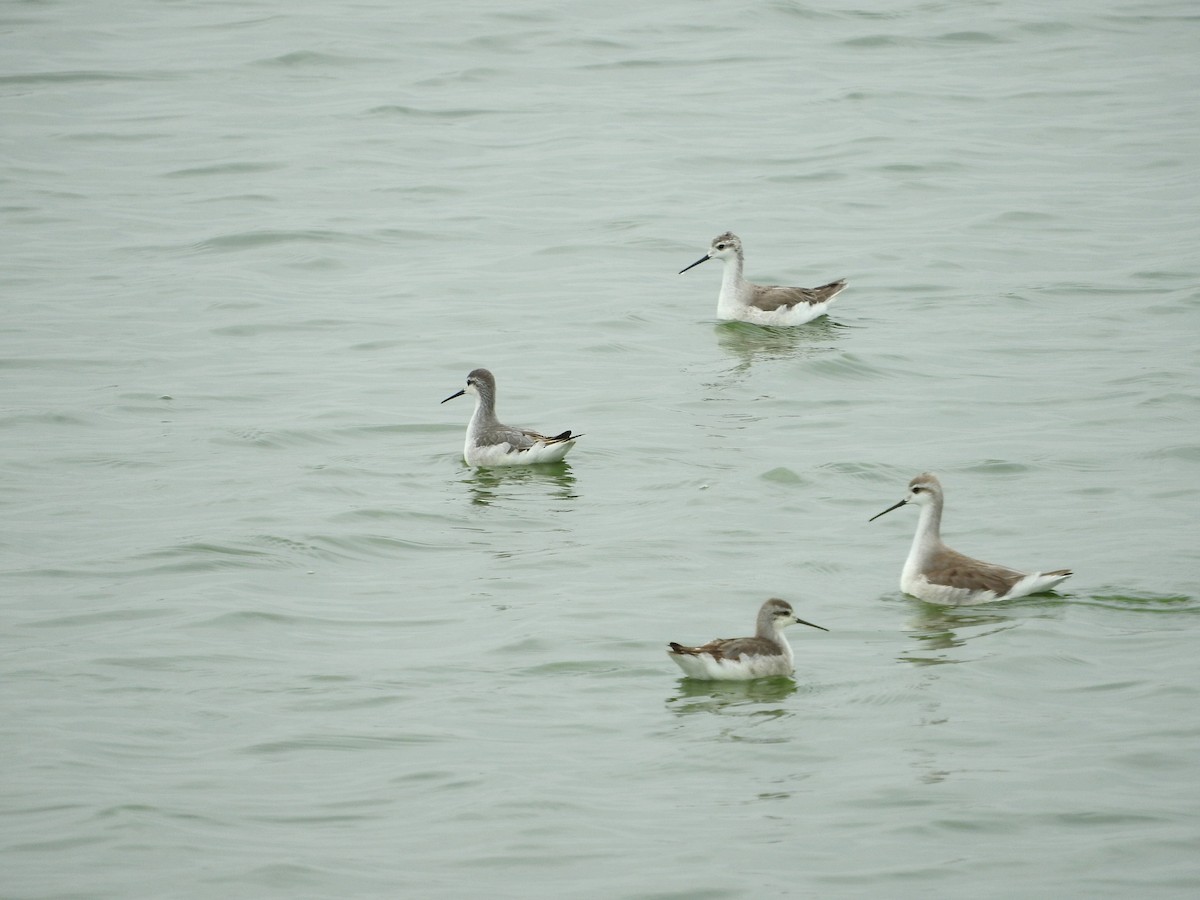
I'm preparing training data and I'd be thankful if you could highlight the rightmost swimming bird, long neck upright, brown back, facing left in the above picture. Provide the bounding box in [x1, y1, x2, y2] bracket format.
[869, 472, 1072, 606]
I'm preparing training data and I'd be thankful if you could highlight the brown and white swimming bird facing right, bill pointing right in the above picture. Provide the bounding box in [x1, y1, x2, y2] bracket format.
[667, 598, 829, 682]
